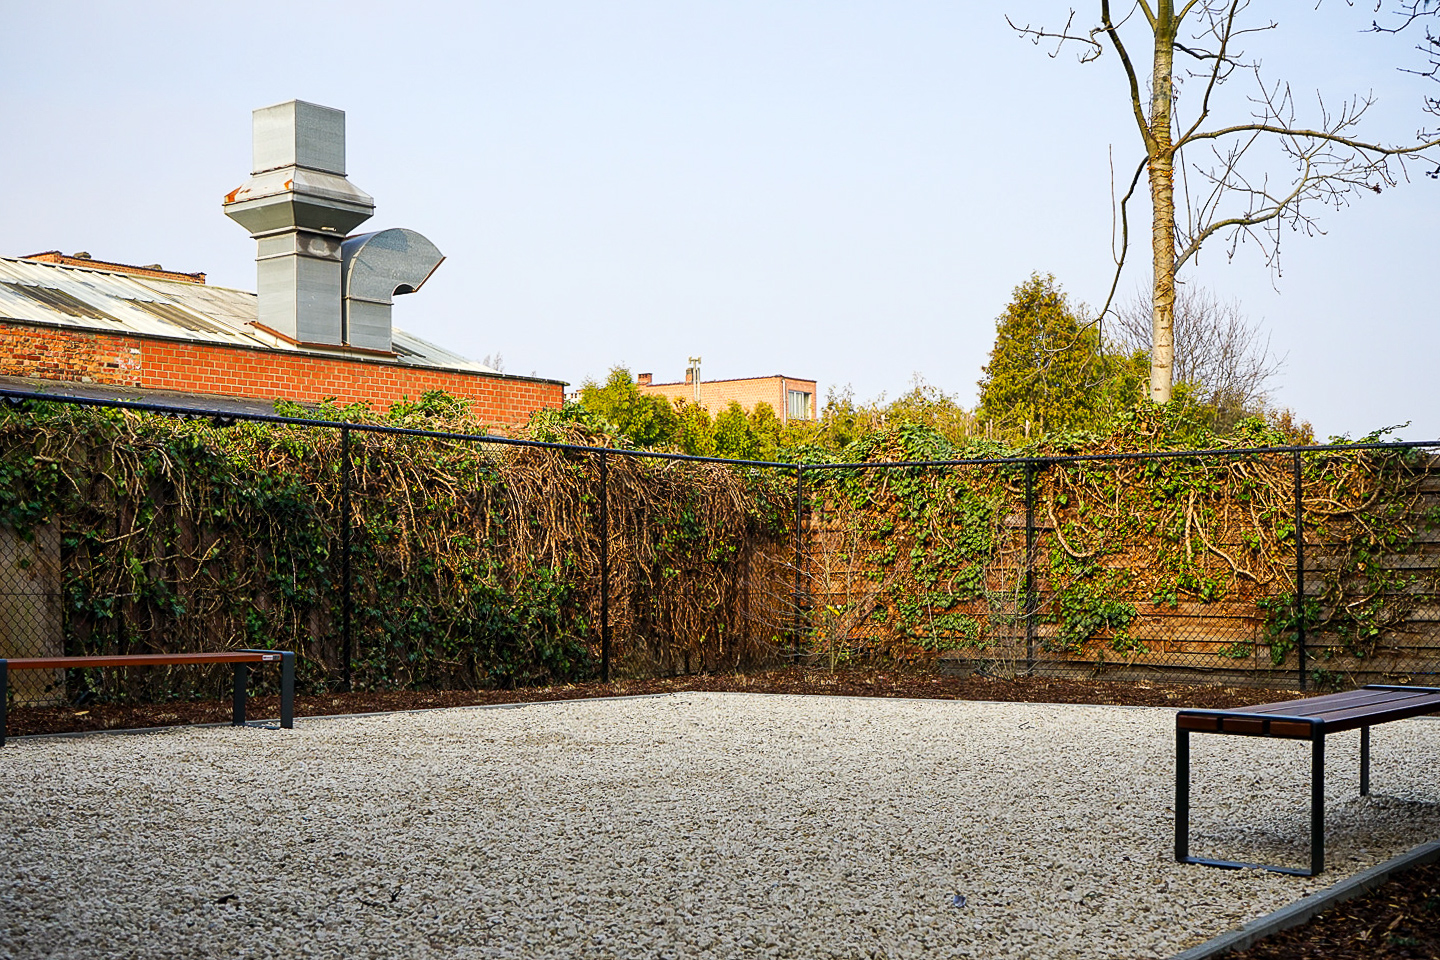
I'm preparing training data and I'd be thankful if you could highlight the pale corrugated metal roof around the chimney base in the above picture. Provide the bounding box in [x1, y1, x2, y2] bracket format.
[0, 258, 498, 373]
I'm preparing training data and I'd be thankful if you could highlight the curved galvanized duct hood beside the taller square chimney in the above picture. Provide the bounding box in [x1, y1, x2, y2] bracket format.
[340, 227, 445, 350]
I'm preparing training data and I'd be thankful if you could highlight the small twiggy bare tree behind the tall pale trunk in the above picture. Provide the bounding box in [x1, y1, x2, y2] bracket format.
[1107, 284, 1284, 419]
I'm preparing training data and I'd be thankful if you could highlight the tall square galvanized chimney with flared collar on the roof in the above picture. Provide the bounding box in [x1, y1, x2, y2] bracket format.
[225, 99, 374, 350]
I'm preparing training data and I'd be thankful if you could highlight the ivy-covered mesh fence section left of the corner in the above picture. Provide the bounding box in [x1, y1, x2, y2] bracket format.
[0, 394, 793, 702]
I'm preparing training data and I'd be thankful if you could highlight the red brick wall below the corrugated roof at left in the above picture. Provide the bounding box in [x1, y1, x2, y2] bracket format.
[0, 322, 564, 426]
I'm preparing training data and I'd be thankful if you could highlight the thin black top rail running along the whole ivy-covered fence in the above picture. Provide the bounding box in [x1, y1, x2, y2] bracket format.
[0, 387, 1440, 474]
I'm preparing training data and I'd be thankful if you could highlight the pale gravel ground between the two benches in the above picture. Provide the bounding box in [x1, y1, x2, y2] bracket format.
[0, 694, 1440, 960]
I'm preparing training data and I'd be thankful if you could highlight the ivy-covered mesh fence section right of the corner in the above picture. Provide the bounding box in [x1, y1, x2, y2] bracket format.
[804, 445, 1440, 689]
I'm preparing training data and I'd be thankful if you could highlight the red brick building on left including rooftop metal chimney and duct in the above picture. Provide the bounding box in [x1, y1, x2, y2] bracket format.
[0, 101, 564, 426]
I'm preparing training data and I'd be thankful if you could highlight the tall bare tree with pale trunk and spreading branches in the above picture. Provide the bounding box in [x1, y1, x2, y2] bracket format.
[1009, 0, 1440, 403]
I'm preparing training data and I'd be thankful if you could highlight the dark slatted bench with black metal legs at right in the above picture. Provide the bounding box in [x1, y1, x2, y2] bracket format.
[1175, 685, 1440, 877]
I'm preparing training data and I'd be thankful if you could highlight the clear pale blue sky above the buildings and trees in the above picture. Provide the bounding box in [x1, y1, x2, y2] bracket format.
[0, 0, 1440, 439]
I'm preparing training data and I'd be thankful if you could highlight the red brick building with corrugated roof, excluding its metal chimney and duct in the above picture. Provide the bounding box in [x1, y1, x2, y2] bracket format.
[0, 250, 564, 426]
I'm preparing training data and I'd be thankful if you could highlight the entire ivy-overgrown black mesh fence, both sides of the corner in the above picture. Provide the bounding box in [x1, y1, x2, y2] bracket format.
[0, 382, 1440, 702]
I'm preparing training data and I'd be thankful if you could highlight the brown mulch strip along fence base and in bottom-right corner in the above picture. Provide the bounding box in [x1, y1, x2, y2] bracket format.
[9, 668, 1440, 960]
